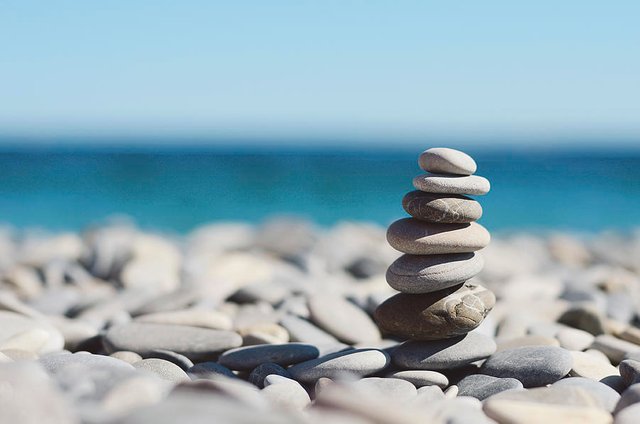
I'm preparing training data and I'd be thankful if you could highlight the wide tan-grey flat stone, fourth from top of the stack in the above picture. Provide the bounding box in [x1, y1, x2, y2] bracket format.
[387, 218, 491, 255]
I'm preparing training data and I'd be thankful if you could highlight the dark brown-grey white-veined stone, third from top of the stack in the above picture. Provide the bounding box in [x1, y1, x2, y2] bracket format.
[402, 190, 482, 224]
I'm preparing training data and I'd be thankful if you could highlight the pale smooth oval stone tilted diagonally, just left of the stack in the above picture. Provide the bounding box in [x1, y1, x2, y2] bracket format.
[308, 293, 380, 344]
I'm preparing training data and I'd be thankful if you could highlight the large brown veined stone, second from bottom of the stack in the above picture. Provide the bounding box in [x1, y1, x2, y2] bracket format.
[375, 283, 495, 340]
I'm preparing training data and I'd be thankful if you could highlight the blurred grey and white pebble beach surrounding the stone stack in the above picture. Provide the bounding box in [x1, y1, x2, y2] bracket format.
[0, 218, 640, 423]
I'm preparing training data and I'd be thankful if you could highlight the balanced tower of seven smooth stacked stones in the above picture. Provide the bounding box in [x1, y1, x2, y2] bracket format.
[375, 148, 495, 369]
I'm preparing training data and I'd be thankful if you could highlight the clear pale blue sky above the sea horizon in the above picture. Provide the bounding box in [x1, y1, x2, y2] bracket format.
[0, 0, 640, 145]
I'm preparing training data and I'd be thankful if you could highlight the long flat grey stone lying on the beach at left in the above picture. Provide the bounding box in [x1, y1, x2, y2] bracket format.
[104, 322, 242, 361]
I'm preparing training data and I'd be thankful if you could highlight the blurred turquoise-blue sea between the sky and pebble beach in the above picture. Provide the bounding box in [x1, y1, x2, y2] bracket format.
[0, 148, 640, 232]
